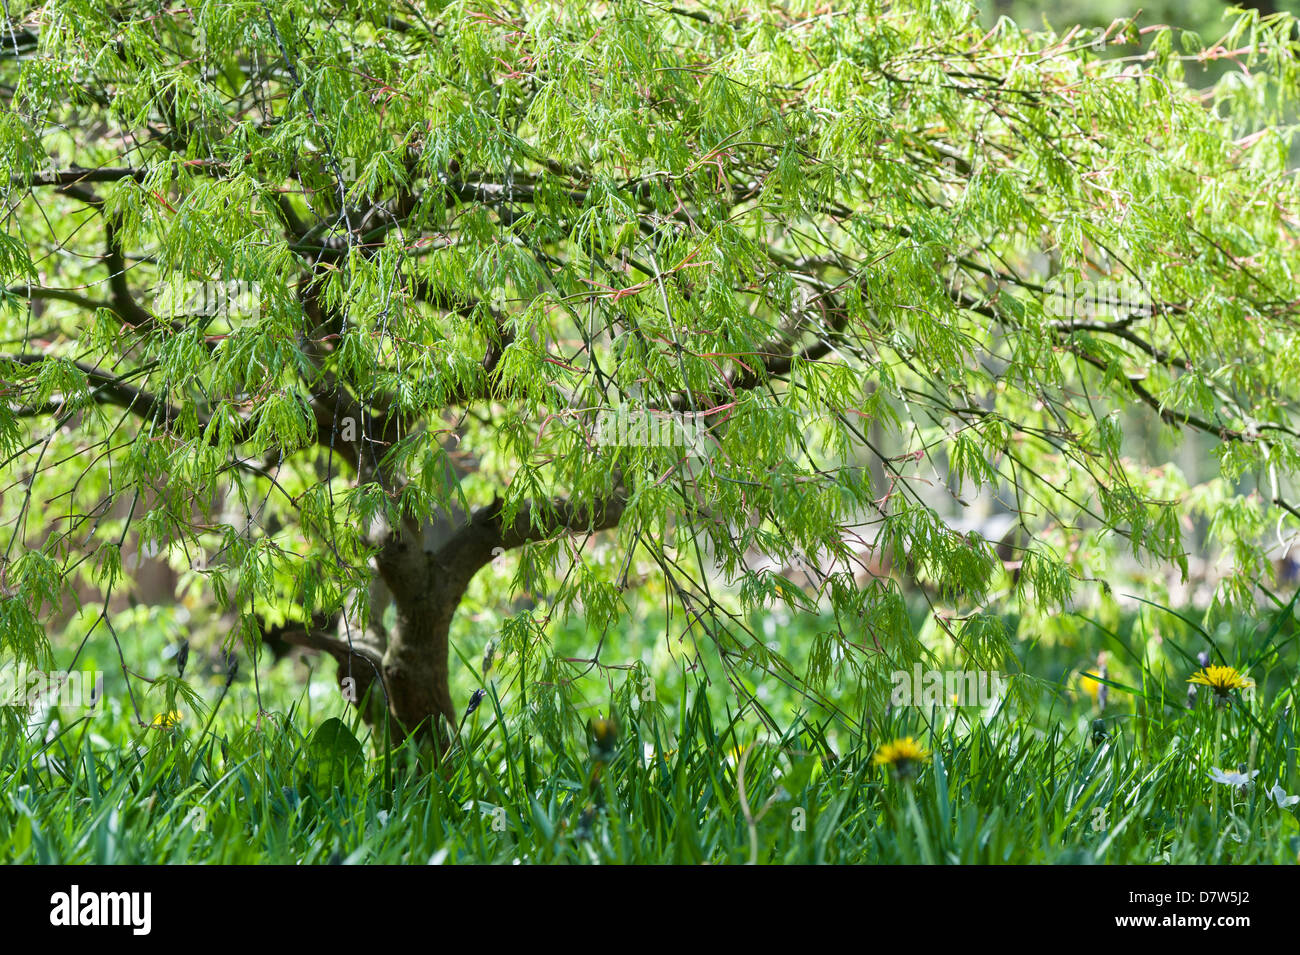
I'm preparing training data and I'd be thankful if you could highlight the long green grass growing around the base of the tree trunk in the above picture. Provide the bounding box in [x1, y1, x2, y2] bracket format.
[0, 595, 1300, 864]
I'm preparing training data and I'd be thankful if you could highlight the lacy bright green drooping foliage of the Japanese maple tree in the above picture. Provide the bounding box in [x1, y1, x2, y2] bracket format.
[0, 0, 1300, 717]
